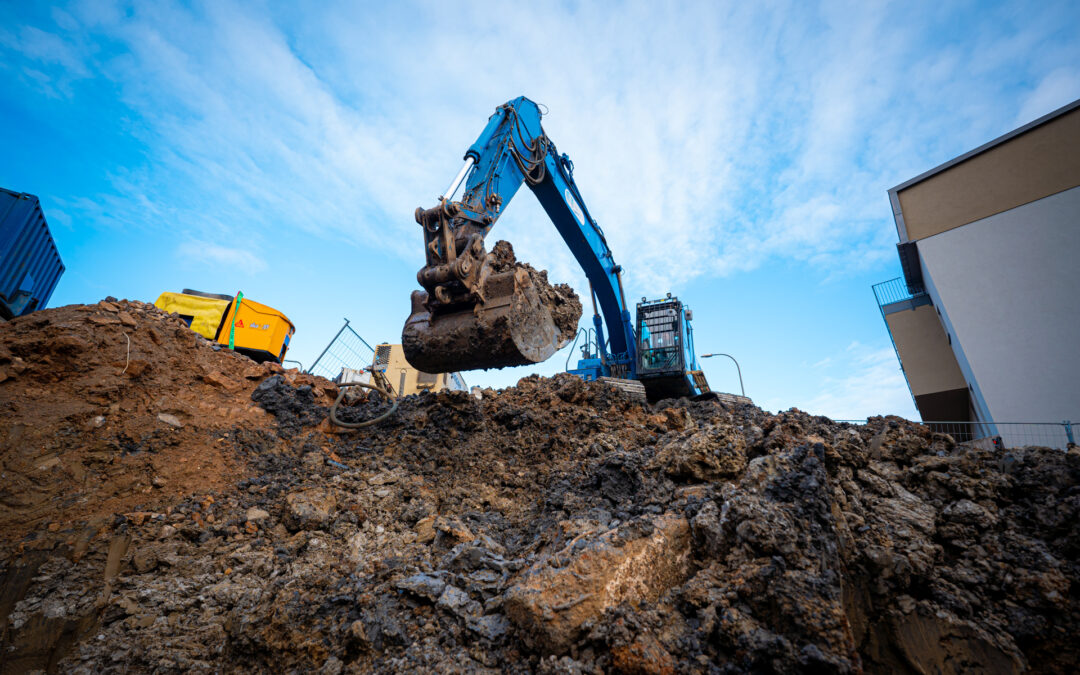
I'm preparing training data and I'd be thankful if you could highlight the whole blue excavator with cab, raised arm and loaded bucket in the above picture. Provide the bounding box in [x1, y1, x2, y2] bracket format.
[402, 96, 710, 401]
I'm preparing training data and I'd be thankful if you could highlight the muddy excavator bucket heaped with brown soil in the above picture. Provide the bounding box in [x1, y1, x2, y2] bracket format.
[402, 267, 561, 373]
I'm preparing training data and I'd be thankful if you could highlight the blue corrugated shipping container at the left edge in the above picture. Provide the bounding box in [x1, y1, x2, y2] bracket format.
[0, 188, 64, 319]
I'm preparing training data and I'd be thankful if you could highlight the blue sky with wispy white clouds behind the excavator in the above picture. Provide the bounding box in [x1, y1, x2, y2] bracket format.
[0, 0, 1080, 419]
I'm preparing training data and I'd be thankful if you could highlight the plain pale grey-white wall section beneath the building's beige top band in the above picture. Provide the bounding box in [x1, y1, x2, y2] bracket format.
[905, 187, 1080, 421]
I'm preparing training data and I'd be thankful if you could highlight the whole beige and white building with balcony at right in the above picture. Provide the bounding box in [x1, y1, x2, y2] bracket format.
[874, 93, 1080, 443]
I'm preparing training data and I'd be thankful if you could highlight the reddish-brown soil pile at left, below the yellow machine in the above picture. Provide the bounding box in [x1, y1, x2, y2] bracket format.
[0, 300, 272, 542]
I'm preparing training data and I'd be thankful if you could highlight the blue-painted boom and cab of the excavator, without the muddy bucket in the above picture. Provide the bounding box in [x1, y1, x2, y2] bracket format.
[445, 96, 708, 397]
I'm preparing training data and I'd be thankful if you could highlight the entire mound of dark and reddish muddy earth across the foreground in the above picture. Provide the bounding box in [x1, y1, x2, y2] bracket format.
[0, 301, 1080, 674]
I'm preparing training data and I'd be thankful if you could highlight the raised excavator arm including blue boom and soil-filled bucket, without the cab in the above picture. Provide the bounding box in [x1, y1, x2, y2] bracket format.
[402, 97, 636, 377]
